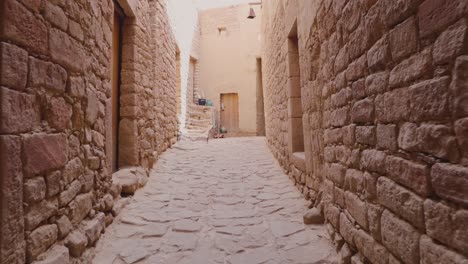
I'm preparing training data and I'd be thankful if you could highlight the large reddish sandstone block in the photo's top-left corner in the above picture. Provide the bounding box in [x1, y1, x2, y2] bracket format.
[3, 0, 48, 55]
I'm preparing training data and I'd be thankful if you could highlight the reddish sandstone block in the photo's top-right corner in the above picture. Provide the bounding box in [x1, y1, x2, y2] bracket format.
[418, 0, 468, 38]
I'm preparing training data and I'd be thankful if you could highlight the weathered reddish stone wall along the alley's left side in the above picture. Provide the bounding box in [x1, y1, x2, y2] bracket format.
[0, 0, 177, 264]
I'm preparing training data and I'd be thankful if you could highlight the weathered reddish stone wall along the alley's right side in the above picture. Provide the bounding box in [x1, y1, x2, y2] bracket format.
[262, 0, 468, 263]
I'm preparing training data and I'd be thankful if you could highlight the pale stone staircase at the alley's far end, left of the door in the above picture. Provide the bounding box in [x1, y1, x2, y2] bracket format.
[182, 105, 213, 141]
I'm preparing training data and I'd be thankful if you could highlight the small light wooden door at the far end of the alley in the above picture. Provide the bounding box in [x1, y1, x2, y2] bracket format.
[221, 93, 239, 133]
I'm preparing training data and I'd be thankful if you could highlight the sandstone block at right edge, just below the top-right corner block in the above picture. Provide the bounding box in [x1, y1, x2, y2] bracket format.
[432, 18, 468, 64]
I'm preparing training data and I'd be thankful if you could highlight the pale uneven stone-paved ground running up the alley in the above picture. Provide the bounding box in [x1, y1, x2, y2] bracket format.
[93, 138, 335, 264]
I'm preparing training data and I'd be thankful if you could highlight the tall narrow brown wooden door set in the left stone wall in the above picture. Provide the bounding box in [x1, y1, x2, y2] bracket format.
[111, 6, 124, 172]
